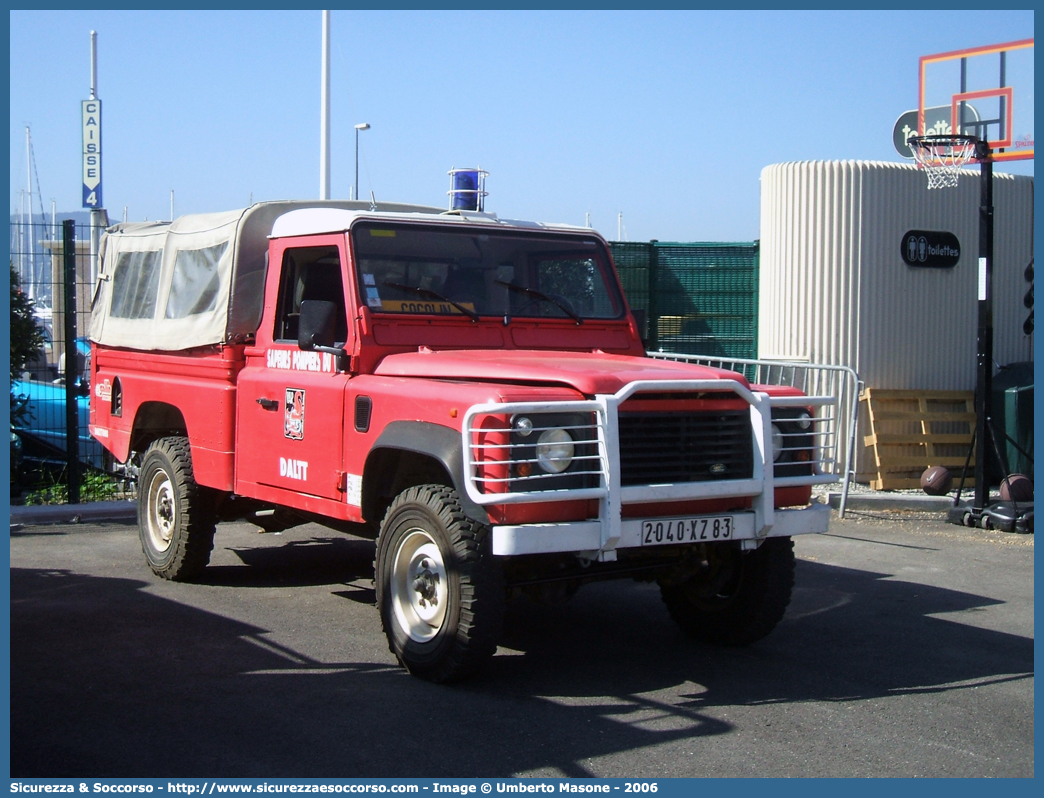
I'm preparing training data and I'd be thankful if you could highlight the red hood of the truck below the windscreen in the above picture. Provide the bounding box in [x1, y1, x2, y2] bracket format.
[375, 349, 750, 396]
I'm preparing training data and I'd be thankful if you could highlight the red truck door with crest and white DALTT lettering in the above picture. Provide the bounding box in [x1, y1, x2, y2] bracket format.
[236, 235, 351, 503]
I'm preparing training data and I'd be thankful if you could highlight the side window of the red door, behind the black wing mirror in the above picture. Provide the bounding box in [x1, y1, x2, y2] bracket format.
[274, 247, 348, 343]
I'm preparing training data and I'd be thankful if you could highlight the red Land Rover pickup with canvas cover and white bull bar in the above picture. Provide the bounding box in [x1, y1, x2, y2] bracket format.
[90, 202, 833, 681]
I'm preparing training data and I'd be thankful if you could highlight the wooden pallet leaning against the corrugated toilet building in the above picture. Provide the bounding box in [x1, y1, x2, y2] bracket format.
[859, 389, 975, 491]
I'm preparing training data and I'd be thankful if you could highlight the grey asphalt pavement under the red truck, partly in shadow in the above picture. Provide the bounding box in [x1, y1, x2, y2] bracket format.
[10, 510, 1034, 778]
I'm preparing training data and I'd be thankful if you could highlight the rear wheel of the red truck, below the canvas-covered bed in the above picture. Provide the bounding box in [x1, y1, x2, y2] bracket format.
[138, 438, 216, 582]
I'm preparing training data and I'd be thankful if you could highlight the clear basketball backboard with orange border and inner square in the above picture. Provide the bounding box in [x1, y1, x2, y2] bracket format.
[918, 39, 1034, 161]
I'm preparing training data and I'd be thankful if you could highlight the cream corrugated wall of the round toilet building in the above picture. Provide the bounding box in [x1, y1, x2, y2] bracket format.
[759, 161, 1034, 390]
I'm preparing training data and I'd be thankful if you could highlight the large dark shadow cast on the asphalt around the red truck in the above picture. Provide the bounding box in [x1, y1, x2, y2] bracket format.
[10, 541, 1033, 777]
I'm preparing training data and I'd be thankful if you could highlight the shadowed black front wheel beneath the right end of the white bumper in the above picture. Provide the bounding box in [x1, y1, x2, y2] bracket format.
[660, 538, 794, 646]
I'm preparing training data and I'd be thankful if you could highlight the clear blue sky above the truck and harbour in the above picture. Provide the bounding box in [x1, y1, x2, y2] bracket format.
[9, 10, 1034, 240]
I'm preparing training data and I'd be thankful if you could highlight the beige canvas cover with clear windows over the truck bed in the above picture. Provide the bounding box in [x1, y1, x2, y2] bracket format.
[88, 201, 441, 351]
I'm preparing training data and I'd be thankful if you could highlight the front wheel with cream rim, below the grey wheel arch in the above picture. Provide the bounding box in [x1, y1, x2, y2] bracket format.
[375, 485, 505, 682]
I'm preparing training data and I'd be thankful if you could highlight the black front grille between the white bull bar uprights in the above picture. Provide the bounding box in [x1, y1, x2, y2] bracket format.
[619, 409, 754, 486]
